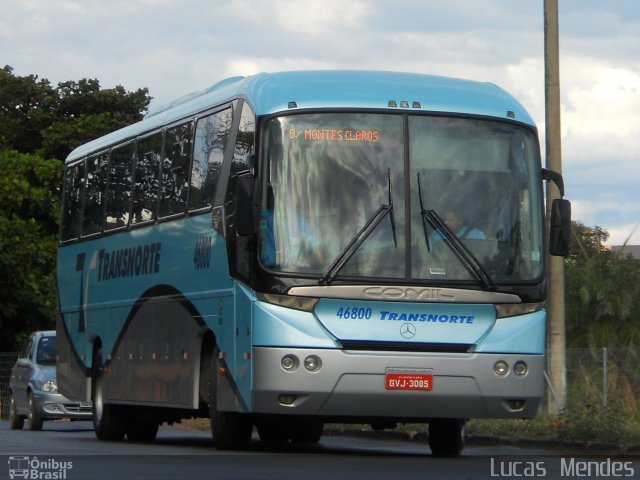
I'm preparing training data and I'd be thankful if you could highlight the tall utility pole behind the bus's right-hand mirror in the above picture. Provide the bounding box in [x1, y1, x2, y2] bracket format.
[544, 0, 567, 415]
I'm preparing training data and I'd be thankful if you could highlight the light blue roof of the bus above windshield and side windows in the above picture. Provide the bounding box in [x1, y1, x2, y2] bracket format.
[67, 70, 534, 162]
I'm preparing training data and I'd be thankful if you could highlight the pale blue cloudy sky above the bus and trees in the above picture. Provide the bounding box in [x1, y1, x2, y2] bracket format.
[0, 0, 640, 245]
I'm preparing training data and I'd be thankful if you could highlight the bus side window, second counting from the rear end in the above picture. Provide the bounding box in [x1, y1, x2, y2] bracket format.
[82, 153, 108, 236]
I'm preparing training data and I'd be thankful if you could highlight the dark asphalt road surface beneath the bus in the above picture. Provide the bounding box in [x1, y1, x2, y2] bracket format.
[0, 421, 640, 480]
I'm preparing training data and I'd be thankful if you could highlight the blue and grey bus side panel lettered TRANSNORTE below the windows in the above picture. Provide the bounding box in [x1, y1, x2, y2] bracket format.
[58, 214, 240, 408]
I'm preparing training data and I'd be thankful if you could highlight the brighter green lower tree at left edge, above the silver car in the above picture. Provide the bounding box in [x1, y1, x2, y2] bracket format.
[0, 150, 62, 351]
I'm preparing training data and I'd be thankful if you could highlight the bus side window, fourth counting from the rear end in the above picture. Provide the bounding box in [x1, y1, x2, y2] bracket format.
[131, 132, 162, 224]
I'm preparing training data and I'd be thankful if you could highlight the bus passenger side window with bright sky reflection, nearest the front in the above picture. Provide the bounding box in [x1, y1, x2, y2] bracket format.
[189, 108, 231, 210]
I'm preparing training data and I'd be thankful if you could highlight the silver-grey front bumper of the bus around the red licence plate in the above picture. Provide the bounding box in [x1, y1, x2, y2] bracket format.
[252, 347, 545, 420]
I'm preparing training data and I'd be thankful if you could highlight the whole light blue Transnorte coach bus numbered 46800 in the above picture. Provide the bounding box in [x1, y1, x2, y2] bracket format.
[57, 71, 569, 455]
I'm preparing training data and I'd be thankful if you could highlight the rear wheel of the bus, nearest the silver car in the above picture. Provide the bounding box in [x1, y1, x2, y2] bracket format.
[91, 350, 125, 441]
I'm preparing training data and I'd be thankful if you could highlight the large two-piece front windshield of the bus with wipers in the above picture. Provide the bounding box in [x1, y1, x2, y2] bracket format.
[260, 113, 543, 289]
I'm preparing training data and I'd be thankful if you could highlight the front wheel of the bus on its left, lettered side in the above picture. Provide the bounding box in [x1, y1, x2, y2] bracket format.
[209, 348, 253, 450]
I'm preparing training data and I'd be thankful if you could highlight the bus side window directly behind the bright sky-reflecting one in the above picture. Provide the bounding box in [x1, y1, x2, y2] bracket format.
[160, 122, 192, 217]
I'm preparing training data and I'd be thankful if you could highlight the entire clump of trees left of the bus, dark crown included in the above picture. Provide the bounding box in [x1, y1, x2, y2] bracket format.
[0, 66, 151, 350]
